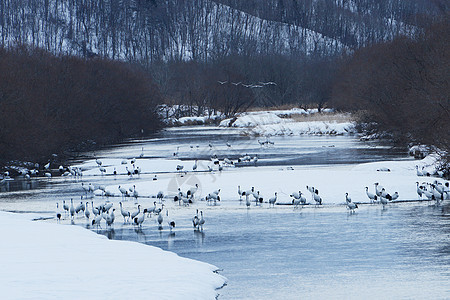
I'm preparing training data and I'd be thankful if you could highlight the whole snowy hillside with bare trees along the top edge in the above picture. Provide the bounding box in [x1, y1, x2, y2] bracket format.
[0, 0, 439, 64]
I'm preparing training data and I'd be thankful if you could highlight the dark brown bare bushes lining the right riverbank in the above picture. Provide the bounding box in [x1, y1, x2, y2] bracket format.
[333, 17, 450, 169]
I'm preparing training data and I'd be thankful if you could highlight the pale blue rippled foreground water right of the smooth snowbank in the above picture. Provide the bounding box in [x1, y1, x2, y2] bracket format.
[96, 203, 450, 299]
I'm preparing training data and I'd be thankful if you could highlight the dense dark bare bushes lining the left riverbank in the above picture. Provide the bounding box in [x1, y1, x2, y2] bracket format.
[0, 47, 161, 162]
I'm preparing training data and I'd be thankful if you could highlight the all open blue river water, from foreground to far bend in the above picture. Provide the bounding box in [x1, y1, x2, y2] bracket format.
[0, 128, 450, 299]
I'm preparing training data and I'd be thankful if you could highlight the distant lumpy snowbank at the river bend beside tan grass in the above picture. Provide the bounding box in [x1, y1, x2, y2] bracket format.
[219, 109, 356, 136]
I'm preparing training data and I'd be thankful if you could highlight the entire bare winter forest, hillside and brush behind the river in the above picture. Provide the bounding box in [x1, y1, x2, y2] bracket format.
[0, 0, 450, 166]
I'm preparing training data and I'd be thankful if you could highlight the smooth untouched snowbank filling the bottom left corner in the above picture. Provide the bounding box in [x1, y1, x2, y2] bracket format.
[0, 212, 225, 299]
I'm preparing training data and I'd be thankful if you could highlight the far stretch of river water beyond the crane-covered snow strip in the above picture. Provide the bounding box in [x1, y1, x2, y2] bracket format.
[91, 127, 407, 165]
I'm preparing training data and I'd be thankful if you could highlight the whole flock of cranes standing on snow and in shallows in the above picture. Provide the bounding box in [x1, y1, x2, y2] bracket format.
[43, 138, 450, 241]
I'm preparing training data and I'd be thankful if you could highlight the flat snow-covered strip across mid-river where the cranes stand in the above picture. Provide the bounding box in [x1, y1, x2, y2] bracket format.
[74, 152, 444, 207]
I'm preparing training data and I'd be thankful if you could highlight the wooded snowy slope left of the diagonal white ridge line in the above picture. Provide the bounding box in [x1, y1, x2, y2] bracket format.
[0, 0, 348, 61]
